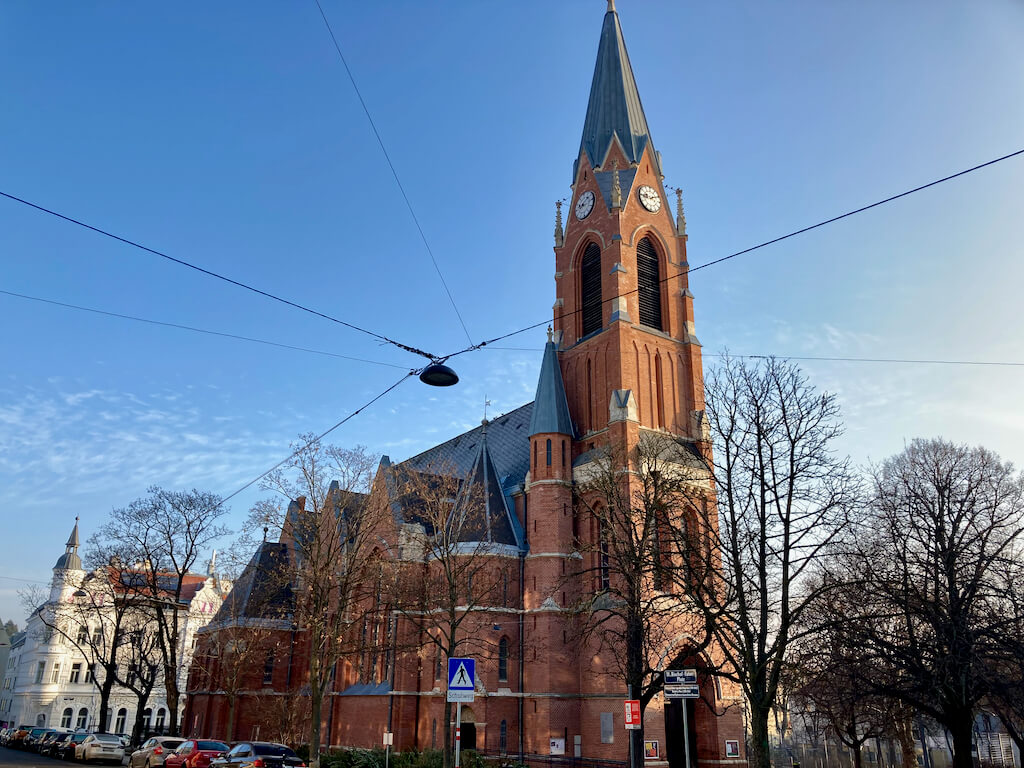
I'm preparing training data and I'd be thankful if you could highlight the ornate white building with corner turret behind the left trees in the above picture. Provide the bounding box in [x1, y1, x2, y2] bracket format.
[0, 518, 226, 733]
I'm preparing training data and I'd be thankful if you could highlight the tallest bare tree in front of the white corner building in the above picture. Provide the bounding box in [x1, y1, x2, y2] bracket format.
[96, 486, 227, 734]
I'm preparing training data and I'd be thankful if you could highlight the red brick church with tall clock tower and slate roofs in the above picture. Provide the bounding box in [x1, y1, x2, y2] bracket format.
[182, 6, 745, 768]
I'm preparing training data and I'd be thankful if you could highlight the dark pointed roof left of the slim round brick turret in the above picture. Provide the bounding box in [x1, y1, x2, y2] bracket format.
[449, 419, 525, 549]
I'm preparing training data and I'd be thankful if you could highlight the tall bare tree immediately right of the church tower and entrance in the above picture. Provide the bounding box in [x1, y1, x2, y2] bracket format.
[673, 357, 857, 768]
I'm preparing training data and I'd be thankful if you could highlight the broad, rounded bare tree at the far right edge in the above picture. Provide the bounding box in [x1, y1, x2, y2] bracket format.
[837, 439, 1024, 768]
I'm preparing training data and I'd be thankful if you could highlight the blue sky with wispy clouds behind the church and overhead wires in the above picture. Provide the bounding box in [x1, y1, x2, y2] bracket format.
[0, 0, 1024, 621]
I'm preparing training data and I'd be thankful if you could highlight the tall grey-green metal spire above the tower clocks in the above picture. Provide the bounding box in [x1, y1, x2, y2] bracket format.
[572, 2, 656, 179]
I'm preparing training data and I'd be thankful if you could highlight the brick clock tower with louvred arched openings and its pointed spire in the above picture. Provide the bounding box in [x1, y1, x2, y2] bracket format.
[554, 1, 703, 455]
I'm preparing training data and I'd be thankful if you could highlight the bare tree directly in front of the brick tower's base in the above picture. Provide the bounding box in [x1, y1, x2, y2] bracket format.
[566, 433, 708, 765]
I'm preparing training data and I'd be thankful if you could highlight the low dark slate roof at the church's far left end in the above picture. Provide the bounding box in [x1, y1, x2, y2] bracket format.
[212, 542, 295, 624]
